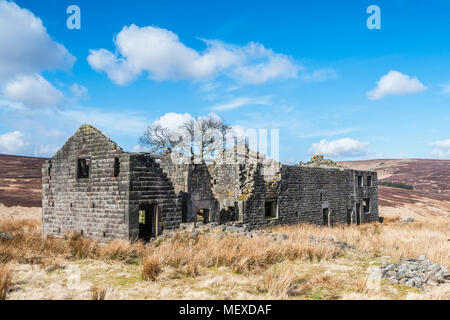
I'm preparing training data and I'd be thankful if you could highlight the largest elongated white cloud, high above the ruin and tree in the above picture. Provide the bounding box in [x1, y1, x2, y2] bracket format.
[88, 24, 299, 85]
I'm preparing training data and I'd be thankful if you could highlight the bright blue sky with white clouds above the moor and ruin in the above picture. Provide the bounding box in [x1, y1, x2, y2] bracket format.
[0, 0, 450, 163]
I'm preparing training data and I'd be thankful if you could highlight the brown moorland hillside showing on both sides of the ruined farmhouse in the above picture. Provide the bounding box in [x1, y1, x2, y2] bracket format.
[0, 155, 450, 215]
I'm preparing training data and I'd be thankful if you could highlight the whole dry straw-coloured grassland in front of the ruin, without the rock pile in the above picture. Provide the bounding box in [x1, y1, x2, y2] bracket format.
[0, 218, 450, 299]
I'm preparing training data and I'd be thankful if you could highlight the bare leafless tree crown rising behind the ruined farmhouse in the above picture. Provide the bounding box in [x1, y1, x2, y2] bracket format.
[139, 115, 230, 160]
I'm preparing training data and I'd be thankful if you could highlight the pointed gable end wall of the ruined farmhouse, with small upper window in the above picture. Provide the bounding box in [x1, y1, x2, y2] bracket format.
[42, 125, 129, 241]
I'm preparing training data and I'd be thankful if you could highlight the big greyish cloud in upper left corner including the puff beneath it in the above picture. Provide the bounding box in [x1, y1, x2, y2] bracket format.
[0, 0, 76, 106]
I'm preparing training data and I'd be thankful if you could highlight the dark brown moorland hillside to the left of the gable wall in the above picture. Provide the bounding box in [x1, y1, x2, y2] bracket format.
[0, 154, 47, 207]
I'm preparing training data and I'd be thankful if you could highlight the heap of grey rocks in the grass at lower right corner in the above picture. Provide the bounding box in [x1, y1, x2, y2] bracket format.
[380, 255, 450, 289]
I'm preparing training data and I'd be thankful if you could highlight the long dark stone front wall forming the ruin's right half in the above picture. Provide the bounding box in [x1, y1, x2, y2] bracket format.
[243, 165, 378, 227]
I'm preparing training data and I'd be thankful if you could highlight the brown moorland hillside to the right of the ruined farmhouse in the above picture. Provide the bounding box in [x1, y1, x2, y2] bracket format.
[340, 159, 450, 216]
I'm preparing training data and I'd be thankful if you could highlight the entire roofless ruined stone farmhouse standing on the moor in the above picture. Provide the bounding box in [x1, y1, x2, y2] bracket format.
[42, 125, 378, 241]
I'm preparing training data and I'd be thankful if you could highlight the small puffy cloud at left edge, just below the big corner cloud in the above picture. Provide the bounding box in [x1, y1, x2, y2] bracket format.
[2, 74, 63, 107]
